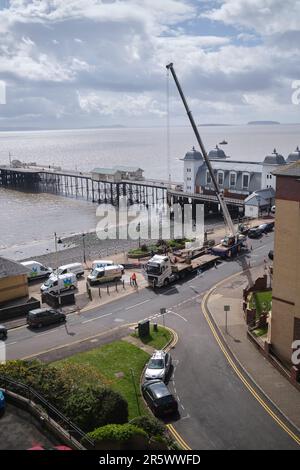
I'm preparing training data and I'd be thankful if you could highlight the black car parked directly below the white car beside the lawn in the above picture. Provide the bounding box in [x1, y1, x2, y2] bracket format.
[142, 379, 178, 416]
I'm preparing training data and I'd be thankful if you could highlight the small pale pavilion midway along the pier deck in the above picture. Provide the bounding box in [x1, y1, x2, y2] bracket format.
[92, 166, 144, 183]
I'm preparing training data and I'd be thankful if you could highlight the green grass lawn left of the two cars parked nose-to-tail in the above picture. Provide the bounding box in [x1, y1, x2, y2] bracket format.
[55, 341, 149, 420]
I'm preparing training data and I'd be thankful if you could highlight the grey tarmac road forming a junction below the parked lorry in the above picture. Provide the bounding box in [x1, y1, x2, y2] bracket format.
[7, 235, 299, 450]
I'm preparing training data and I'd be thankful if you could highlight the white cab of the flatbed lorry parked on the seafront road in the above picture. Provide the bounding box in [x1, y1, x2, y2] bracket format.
[144, 255, 172, 287]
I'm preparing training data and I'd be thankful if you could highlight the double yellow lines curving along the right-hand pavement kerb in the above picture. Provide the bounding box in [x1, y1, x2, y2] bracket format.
[201, 280, 300, 445]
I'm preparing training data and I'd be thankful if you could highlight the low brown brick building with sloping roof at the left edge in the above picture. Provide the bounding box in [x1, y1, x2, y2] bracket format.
[0, 257, 29, 305]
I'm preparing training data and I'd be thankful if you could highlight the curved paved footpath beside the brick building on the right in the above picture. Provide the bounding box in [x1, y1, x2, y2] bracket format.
[203, 267, 300, 429]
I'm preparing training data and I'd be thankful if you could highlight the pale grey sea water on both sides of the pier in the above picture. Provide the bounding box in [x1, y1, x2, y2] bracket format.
[0, 124, 300, 259]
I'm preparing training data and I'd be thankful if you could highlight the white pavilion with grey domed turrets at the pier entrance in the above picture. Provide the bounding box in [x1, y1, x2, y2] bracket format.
[182, 146, 300, 199]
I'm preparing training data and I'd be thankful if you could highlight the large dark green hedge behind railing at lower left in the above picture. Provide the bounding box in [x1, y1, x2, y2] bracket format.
[0, 361, 128, 432]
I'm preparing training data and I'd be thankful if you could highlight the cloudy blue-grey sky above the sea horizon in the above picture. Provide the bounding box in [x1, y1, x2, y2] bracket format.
[0, 0, 300, 129]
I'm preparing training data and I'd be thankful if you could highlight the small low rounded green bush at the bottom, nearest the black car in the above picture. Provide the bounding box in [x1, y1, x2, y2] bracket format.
[88, 423, 148, 443]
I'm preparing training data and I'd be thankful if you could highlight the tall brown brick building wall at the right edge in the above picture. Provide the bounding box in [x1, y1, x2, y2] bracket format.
[270, 160, 300, 364]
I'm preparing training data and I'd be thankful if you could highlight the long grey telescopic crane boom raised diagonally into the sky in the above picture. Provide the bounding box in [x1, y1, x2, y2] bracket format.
[166, 63, 235, 236]
